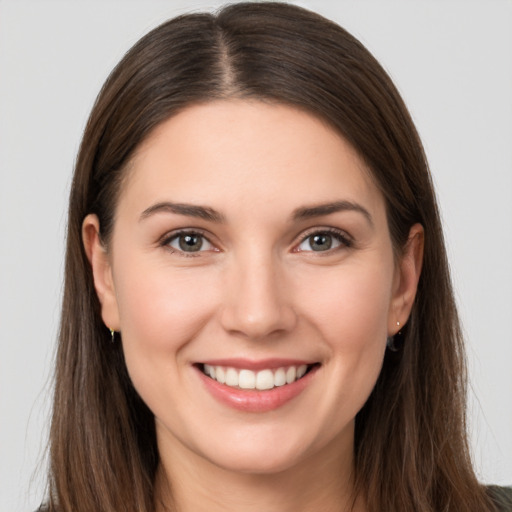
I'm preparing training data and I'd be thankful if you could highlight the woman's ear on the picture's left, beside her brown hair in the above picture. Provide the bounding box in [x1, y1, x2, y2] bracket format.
[82, 214, 120, 331]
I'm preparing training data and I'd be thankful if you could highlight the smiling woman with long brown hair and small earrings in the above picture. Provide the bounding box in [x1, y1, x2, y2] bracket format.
[41, 2, 510, 511]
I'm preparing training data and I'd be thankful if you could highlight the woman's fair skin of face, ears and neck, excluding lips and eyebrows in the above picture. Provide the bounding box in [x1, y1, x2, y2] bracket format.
[83, 100, 423, 512]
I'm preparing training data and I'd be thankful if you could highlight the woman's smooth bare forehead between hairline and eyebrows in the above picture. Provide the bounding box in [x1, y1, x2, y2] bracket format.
[121, 100, 383, 220]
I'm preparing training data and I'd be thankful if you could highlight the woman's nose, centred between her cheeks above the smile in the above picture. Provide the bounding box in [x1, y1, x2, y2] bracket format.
[221, 252, 297, 340]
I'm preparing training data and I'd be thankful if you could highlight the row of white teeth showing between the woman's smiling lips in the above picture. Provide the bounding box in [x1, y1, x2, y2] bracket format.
[198, 363, 320, 391]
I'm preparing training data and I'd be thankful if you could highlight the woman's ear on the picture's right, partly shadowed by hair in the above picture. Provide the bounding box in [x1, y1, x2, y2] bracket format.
[388, 224, 424, 336]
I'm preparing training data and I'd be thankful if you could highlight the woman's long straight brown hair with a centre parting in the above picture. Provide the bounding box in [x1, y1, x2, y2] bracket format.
[49, 2, 494, 512]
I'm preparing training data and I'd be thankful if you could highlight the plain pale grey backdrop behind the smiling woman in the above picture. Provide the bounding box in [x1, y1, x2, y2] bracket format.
[0, 0, 512, 512]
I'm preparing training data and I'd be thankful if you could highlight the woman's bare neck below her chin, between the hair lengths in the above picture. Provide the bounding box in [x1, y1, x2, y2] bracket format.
[155, 428, 364, 512]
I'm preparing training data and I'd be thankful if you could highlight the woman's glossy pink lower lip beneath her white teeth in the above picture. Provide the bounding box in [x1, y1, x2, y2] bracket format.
[196, 366, 318, 412]
